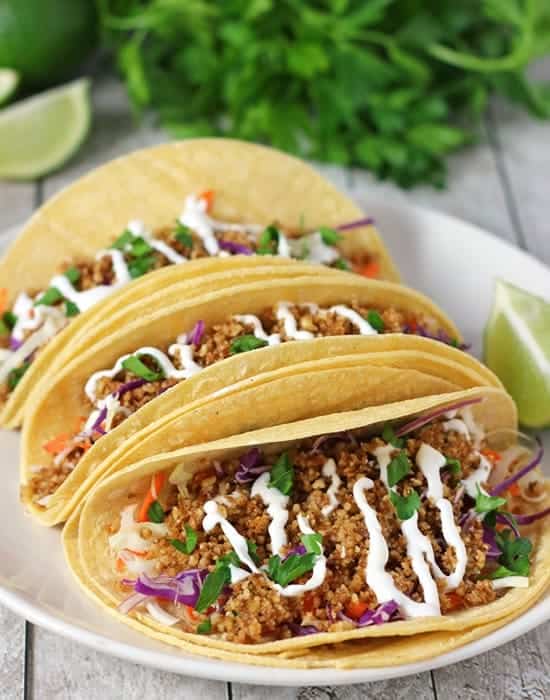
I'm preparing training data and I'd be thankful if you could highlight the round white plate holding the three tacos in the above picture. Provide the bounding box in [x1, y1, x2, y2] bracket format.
[0, 200, 550, 686]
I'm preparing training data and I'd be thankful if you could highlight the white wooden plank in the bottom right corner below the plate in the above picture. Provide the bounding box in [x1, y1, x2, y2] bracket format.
[434, 625, 550, 700]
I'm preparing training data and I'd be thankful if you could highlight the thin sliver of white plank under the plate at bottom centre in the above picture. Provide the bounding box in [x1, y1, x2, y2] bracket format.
[232, 673, 436, 700]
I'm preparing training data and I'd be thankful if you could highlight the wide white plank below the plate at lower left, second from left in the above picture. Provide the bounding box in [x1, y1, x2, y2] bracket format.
[30, 628, 226, 700]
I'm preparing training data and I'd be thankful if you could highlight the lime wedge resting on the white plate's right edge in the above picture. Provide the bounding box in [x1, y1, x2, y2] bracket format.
[485, 280, 550, 428]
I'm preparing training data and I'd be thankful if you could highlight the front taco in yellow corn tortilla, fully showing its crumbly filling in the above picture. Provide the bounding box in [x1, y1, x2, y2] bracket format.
[64, 386, 550, 668]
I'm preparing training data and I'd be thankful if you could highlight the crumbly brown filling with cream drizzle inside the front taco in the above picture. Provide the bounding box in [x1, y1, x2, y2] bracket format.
[108, 399, 549, 644]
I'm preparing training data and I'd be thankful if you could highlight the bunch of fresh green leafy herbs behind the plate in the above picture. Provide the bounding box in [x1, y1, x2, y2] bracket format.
[98, 0, 550, 187]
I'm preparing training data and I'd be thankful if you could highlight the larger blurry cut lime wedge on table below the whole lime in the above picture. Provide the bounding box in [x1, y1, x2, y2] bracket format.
[0, 79, 91, 180]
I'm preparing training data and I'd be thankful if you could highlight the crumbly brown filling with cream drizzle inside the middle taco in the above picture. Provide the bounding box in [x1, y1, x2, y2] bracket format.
[26, 302, 464, 507]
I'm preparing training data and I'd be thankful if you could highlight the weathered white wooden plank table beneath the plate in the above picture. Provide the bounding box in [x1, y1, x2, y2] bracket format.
[0, 63, 550, 700]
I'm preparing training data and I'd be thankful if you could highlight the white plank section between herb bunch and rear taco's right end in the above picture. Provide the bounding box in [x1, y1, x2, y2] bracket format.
[349, 123, 515, 246]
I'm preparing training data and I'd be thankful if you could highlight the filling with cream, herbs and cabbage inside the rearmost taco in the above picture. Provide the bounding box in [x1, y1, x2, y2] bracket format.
[0, 192, 379, 403]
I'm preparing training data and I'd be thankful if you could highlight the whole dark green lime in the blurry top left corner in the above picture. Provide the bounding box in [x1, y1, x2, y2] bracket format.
[0, 0, 98, 88]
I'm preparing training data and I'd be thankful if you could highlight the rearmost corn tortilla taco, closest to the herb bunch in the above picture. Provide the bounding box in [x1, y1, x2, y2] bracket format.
[0, 139, 397, 425]
